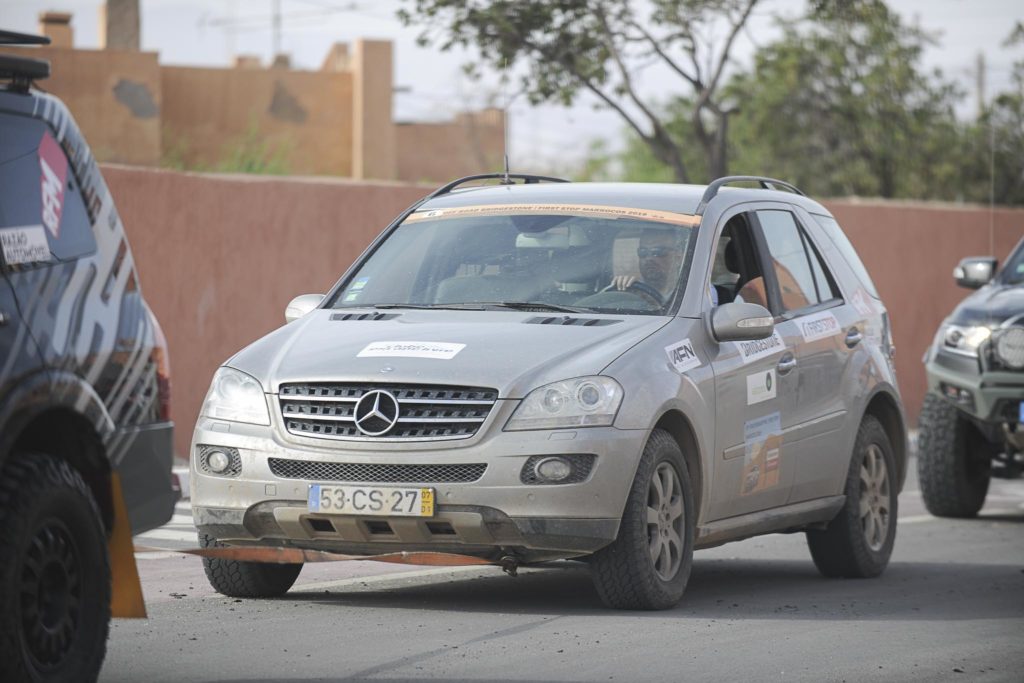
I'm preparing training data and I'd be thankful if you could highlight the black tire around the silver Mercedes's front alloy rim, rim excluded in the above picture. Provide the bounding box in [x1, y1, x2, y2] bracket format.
[590, 429, 694, 609]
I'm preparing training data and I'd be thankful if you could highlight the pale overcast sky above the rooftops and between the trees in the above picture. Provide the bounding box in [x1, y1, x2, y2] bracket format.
[0, 0, 1024, 170]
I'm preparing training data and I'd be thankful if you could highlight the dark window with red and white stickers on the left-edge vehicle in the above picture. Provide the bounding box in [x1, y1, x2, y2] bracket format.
[0, 114, 96, 268]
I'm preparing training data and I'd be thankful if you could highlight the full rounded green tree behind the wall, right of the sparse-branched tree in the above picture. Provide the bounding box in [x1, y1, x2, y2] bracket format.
[728, 0, 961, 199]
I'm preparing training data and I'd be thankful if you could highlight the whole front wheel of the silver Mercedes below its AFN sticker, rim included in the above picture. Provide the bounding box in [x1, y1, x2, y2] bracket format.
[590, 429, 694, 609]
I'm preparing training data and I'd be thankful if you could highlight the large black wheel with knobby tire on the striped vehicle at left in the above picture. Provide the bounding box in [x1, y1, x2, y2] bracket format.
[0, 455, 111, 681]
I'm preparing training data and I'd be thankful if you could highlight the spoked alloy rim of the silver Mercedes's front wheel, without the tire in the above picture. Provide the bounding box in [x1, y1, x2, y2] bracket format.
[647, 463, 686, 581]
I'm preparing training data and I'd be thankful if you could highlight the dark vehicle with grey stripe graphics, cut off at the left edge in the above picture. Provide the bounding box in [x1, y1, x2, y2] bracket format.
[0, 32, 178, 681]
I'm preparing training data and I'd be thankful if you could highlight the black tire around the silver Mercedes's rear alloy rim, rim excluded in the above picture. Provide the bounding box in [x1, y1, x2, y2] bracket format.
[807, 415, 898, 579]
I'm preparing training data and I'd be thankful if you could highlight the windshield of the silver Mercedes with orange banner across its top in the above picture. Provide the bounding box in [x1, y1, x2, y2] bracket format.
[331, 205, 699, 314]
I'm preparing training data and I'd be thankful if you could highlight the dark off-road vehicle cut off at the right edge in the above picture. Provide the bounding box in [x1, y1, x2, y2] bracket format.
[918, 240, 1024, 517]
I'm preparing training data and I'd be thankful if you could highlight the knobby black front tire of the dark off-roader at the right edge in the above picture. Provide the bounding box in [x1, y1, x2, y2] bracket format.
[918, 393, 992, 517]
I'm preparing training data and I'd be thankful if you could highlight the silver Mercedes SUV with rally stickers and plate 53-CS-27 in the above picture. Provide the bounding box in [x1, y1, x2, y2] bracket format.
[191, 174, 906, 609]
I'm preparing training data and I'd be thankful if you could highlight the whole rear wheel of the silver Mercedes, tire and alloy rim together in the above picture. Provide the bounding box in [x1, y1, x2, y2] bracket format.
[807, 415, 897, 579]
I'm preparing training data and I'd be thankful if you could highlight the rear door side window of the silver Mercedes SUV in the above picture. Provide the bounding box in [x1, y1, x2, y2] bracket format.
[757, 211, 836, 311]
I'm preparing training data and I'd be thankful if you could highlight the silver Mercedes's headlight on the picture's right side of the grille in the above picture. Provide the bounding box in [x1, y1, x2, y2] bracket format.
[505, 377, 623, 431]
